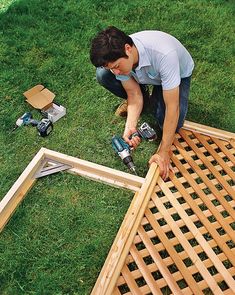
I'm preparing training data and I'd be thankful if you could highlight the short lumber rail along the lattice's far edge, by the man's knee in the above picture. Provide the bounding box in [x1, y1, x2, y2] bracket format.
[183, 120, 235, 143]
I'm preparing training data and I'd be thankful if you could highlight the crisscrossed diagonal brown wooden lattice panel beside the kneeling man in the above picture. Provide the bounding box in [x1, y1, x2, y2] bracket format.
[114, 130, 235, 295]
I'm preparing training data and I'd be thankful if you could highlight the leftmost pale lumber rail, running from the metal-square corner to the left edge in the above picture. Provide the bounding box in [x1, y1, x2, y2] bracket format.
[0, 148, 45, 232]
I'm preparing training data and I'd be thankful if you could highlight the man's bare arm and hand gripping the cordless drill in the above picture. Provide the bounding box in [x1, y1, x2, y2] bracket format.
[122, 78, 143, 148]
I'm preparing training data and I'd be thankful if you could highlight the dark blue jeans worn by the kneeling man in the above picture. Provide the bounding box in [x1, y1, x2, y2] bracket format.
[96, 68, 191, 131]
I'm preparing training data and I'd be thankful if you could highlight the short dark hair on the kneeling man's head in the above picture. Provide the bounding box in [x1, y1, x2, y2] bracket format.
[90, 26, 133, 67]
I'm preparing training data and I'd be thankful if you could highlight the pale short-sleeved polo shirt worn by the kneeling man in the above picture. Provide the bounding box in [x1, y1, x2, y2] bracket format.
[116, 31, 194, 90]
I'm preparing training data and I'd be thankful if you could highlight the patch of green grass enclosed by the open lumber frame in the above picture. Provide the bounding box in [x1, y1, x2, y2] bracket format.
[0, 174, 130, 294]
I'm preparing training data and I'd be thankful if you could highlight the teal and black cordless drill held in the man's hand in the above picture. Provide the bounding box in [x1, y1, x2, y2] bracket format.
[112, 122, 157, 175]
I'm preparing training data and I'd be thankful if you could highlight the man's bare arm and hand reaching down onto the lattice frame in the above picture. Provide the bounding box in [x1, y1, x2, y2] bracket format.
[149, 87, 179, 180]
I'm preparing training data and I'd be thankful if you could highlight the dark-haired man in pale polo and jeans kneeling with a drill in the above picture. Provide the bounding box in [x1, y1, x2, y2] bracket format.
[90, 27, 194, 180]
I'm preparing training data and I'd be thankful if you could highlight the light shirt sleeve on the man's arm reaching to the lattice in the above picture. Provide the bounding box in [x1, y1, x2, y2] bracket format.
[160, 50, 181, 90]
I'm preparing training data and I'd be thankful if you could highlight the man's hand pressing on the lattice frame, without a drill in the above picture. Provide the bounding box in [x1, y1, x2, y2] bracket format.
[149, 151, 174, 180]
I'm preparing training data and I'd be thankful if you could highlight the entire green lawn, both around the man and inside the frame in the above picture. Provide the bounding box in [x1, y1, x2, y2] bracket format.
[0, 0, 235, 295]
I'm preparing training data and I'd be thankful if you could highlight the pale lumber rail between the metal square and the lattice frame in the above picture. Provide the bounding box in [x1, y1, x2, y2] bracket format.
[45, 149, 144, 191]
